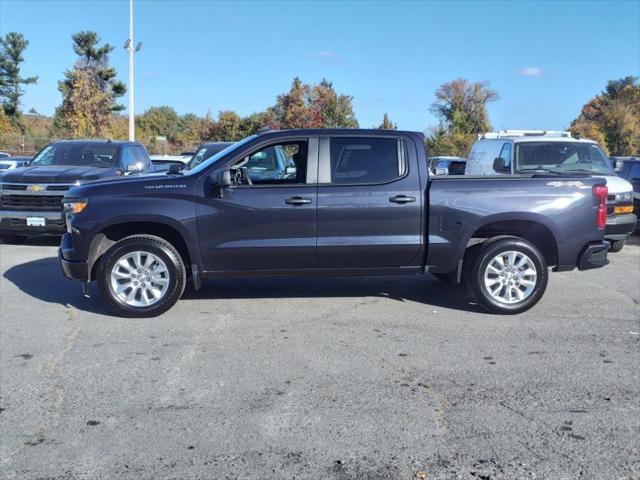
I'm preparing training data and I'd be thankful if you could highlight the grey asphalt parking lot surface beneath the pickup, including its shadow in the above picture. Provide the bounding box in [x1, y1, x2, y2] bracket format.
[0, 240, 640, 480]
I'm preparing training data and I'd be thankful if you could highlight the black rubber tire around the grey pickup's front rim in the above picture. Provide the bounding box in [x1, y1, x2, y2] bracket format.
[96, 235, 187, 318]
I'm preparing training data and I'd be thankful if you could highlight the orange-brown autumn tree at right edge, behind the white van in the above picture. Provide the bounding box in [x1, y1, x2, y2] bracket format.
[570, 76, 640, 155]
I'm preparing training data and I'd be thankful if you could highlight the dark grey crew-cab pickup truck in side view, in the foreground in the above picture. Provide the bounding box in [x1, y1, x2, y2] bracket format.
[59, 130, 609, 317]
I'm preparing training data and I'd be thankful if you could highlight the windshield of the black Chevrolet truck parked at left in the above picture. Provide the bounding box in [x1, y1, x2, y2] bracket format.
[30, 143, 118, 168]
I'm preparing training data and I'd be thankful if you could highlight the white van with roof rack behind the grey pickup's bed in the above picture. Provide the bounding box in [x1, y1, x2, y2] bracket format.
[465, 130, 636, 252]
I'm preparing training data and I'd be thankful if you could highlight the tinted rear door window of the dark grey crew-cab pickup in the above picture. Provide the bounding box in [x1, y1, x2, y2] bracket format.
[330, 137, 406, 184]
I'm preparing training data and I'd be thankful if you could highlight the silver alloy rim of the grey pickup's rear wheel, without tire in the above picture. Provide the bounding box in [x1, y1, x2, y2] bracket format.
[484, 251, 538, 304]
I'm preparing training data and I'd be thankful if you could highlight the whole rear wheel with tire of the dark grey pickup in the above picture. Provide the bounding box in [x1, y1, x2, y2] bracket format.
[464, 237, 549, 314]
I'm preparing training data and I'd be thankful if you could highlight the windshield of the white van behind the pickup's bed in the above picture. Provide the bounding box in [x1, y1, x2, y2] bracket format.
[515, 142, 615, 175]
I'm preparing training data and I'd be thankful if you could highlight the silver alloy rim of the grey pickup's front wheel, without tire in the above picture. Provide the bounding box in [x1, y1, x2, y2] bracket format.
[111, 252, 169, 308]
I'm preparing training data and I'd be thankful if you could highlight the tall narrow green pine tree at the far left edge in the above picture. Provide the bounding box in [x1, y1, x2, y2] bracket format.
[0, 32, 38, 120]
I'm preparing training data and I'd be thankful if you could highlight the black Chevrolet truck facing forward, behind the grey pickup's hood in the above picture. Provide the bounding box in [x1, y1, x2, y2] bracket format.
[0, 140, 154, 243]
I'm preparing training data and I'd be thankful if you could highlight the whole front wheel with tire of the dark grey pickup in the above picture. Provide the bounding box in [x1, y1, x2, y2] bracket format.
[96, 235, 186, 318]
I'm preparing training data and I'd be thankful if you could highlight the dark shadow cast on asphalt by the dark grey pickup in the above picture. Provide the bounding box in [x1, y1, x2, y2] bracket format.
[4, 257, 483, 314]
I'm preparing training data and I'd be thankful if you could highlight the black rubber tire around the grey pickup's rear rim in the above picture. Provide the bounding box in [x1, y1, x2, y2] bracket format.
[463, 237, 549, 315]
